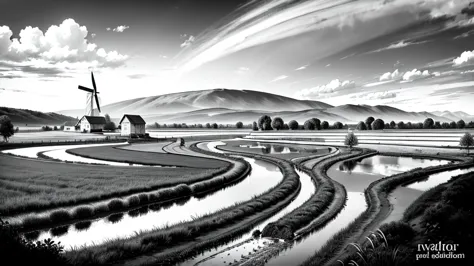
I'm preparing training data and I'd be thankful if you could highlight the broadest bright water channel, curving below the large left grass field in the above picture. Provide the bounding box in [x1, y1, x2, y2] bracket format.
[35, 159, 283, 248]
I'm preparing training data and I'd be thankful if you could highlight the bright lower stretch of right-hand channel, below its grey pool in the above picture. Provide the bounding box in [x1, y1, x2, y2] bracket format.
[265, 192, 367, 266]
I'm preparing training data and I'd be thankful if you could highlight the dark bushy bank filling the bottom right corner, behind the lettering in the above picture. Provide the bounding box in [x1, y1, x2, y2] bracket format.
[336, 172, 474, 266]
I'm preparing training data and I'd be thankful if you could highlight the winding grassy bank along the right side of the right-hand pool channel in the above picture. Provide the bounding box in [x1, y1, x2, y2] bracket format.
[303, 154, 473, 265]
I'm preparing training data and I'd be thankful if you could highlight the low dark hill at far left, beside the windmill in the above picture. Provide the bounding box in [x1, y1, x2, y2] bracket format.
[0, 107, 77, 126]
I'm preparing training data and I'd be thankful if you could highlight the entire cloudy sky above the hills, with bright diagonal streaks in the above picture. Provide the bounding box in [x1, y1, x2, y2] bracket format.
[0, 0, 474, 114]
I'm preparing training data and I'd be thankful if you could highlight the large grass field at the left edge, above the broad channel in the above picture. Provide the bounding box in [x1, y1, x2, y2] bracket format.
[0, 155, 225, 215]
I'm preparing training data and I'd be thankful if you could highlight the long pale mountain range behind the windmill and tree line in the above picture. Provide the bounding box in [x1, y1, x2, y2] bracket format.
[58, 89, 474, 124]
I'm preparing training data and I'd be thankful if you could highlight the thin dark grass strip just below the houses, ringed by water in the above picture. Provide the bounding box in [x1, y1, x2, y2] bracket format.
[68, 144, 229, 169]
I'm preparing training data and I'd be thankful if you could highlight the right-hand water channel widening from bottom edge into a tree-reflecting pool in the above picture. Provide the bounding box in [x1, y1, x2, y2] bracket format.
[266, 155, 447, 266]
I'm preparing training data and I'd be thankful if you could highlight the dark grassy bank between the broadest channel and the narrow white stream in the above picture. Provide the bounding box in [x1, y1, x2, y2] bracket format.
[67, 154, 300, 265]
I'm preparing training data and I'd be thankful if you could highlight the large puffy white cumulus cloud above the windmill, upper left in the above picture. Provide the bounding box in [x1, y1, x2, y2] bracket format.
[0, 19, 128, 71]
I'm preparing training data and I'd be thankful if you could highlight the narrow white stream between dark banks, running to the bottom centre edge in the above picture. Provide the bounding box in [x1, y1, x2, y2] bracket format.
[181, 168, 315, 266]
